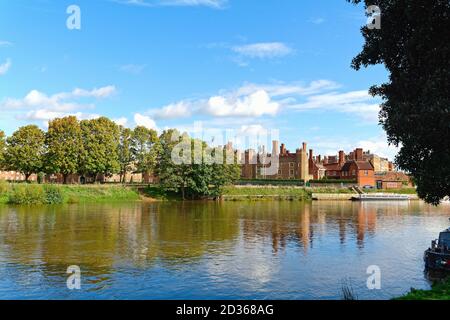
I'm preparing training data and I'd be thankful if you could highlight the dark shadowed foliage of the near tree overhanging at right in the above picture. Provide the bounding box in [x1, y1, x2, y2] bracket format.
[348, 0, 450, 205]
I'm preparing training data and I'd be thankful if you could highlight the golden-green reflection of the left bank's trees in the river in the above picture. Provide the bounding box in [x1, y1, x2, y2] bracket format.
[0, 203, 238, 276]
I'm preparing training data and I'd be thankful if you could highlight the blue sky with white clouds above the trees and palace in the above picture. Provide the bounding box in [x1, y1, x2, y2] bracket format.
[0, 0, 396, 159]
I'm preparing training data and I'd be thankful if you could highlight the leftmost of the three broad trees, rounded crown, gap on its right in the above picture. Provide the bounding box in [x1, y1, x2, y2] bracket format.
[5, 125, 45, 181]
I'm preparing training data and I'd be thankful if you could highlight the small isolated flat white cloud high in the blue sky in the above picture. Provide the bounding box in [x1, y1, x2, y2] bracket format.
[232, 42, 293, 59]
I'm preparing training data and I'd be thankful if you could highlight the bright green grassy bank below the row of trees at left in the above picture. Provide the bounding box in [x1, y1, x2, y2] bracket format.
[0, 183, 140, 205]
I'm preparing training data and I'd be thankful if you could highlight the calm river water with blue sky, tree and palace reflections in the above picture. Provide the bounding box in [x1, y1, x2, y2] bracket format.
[0, 201, 450, 299]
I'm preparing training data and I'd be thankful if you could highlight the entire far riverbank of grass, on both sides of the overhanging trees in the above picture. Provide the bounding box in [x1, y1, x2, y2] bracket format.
[0, 182, 415, 204]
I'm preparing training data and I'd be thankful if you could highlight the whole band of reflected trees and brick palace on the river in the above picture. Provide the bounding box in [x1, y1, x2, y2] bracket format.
[0, 201, 438, 282]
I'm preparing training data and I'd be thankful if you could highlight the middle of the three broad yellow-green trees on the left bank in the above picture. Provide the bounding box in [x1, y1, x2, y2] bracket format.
[46, 116, 83, 184]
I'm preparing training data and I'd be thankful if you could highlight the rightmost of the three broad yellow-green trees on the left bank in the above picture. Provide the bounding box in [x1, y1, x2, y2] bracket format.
[80, 117, 120, 181]
